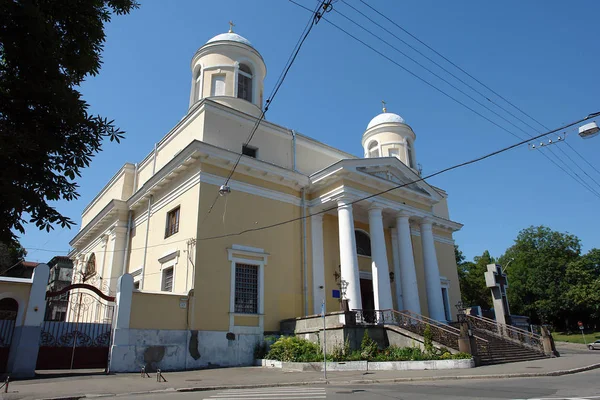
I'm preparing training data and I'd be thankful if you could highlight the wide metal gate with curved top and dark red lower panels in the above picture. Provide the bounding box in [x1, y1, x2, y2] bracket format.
[36, 283, 115, 370]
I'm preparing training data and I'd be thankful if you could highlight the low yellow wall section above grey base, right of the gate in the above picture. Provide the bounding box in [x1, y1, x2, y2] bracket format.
[129, 292, 188, 329]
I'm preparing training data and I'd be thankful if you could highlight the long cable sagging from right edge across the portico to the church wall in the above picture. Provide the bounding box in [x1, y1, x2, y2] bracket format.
[198, 112, 600, 241]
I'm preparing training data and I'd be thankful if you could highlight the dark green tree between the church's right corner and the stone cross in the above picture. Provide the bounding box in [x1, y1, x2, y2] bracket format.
[454, 245, 495, 309]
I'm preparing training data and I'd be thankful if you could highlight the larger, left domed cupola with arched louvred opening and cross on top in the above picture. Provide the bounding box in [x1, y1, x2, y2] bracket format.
[185, 22, 267, 117]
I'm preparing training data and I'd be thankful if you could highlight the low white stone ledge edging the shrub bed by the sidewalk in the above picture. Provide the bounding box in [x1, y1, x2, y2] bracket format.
[255, 358, 475, 371]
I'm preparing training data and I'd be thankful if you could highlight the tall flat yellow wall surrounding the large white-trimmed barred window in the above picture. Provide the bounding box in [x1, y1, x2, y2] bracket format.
[194, 183, 304, 331]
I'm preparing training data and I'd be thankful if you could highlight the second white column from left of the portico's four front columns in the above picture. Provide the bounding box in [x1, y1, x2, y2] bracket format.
[369, 205, 394, 310]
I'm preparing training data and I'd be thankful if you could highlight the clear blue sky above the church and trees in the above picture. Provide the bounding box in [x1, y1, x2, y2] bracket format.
[21, 0, 600, 262]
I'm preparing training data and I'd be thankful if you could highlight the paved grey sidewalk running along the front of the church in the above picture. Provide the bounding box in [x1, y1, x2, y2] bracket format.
[0, 344, 600, 399]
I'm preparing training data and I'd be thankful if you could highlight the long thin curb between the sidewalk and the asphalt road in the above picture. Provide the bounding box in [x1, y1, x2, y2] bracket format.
[35, 363, 600, 400]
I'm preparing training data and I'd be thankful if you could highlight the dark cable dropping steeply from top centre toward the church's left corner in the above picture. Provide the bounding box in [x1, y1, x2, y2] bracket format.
[202, 0, 332, 223]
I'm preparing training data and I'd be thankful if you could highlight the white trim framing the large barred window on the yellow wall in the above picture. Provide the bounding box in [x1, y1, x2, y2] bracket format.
[227, 244, 269, 334]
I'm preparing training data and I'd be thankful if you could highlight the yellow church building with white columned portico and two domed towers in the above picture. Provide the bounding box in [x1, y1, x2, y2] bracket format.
[70, 32, 462, 369]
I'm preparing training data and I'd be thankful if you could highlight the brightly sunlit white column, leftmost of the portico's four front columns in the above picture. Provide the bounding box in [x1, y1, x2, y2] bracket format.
[338, 198, 362, 310]
